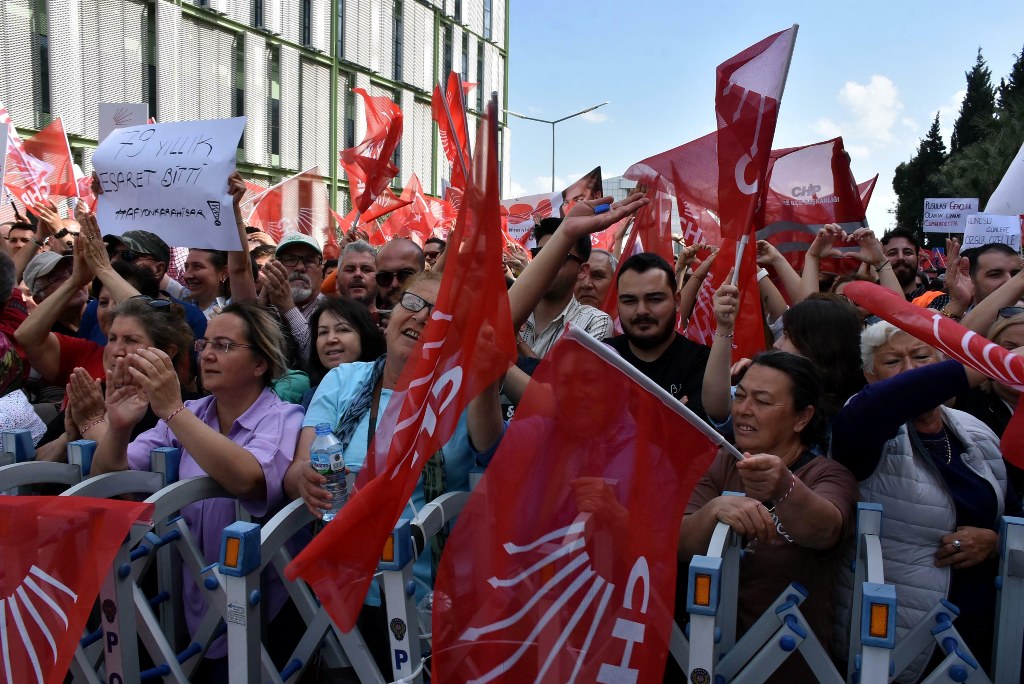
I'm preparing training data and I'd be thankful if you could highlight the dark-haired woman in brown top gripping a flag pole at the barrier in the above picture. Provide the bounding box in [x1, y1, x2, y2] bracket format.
[679, 351, 857, 681]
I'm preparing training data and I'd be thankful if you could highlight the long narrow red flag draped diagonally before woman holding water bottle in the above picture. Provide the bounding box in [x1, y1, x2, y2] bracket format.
[286, 94, 515, 631]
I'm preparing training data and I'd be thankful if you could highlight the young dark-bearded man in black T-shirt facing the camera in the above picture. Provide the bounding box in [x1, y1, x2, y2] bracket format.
[607, 252, 711, 418]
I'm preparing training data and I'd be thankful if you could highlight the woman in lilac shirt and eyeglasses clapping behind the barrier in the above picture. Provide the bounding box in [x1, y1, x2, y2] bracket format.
[92, 303, 302, 681]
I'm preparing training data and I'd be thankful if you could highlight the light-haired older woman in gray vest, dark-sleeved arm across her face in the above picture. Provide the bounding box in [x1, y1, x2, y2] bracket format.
[831, 323, 1020, 681]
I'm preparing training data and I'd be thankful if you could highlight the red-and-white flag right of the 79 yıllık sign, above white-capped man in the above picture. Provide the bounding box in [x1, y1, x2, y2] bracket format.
[241, 166, 337, 246]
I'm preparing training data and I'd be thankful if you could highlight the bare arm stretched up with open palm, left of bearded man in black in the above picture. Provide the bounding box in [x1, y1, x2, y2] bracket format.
[509, 193, 648, 330]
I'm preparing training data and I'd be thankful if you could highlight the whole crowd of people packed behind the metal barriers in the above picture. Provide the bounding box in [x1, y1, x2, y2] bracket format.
[0, 179, 1024, 681]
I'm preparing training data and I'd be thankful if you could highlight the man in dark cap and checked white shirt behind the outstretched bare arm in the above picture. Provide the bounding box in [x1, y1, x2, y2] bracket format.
[521, 218, 612, 358]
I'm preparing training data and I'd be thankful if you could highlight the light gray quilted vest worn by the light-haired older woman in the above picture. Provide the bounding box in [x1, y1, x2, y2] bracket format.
[833, 407, 1007, 682]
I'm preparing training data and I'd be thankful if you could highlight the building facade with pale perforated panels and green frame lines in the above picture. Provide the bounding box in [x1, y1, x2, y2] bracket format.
[0, 0, 510, 210]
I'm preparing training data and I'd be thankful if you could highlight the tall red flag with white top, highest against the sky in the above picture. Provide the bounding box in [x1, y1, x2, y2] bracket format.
[715, 27, 797, 240]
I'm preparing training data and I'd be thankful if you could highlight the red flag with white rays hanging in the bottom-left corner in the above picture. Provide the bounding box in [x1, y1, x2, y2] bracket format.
[0, 497, 153, 684]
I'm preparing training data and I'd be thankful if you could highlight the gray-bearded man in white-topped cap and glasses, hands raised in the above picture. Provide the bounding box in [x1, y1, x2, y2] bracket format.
[259, 232, 324, 364]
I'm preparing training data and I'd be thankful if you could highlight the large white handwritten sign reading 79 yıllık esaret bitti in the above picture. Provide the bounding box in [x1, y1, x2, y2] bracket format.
[92, 117, 246, 250]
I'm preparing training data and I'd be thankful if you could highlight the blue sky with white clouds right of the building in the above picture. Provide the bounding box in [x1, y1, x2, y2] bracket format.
[505, 0, 1024, 232]
